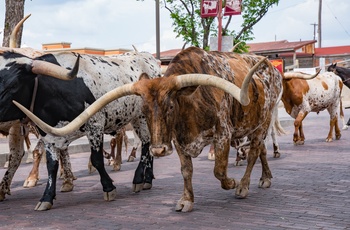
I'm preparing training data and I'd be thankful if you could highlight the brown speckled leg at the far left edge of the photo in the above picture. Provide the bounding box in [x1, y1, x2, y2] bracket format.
[0, 124, 24, 201]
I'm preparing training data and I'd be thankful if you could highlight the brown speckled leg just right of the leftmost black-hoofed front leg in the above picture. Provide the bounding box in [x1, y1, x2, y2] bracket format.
[60, 149, 77, 192]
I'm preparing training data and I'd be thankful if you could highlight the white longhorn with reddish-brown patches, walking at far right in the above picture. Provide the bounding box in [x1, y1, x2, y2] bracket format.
[282, 72, 344, 145]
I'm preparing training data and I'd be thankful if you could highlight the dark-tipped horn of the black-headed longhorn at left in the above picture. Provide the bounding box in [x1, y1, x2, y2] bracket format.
[31, 55, 80, 80]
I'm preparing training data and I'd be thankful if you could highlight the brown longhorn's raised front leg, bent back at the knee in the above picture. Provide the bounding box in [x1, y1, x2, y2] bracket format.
[214, 140, 237, 190]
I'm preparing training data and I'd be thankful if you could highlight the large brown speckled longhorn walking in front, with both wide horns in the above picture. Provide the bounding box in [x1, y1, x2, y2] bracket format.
[16, 47, 288, 212]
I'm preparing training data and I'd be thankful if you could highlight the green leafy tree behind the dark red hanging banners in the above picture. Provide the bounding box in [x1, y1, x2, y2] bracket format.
[137, 0, 279, 51]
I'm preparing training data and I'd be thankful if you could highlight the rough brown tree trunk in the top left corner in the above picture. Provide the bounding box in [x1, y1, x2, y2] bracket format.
[2, 0, 25, 47]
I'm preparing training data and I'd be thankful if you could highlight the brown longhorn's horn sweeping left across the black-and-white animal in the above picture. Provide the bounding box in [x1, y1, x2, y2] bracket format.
[12, 83, 134, 136]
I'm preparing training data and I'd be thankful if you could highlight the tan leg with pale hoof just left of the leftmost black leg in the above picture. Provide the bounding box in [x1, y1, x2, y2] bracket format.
[23, 139, 45, 188]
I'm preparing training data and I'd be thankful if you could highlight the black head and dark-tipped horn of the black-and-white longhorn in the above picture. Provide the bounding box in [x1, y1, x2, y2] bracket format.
[0, 49, 79, 121]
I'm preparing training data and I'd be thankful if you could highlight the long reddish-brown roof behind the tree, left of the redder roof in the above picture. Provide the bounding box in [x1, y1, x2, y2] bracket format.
[247, 40, 317, 54]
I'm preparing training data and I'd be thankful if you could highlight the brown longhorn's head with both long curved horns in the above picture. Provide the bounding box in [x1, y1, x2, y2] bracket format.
[14, 58, 266, 156]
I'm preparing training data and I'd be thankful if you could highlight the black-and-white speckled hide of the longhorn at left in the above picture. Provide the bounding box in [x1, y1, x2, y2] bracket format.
[0, 49, 160, 210]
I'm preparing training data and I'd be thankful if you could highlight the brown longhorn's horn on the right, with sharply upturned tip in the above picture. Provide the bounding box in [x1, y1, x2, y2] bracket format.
[176, 57, 267, 106]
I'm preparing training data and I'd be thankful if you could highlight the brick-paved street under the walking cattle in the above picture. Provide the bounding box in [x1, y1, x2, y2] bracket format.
[0, 110, 350, 229]
